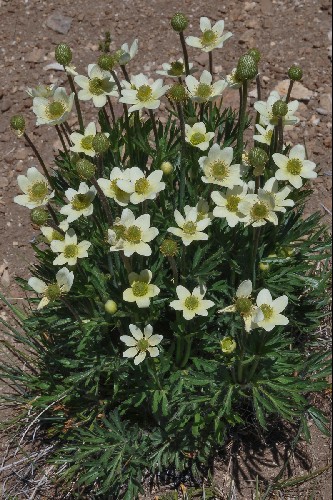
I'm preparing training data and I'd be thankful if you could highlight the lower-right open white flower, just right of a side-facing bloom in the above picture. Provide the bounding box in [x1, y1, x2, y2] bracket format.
[254, 288, 289, 332]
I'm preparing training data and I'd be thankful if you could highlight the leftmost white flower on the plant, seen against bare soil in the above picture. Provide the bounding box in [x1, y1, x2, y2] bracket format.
[14, 167, 54, 209]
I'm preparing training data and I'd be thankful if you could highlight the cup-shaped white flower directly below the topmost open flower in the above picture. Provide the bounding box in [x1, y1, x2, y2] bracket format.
[185, 70, 228, 102]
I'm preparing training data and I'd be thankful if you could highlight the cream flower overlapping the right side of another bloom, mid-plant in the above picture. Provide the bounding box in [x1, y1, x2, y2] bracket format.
[117, 167, 165, 205]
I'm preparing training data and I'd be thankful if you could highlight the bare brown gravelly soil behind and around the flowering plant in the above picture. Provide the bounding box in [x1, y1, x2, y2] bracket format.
[0, 0, 332, 500]
